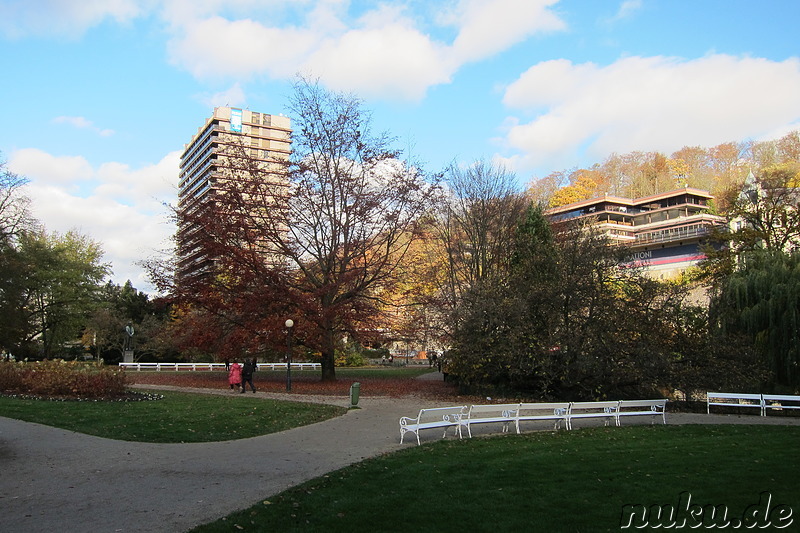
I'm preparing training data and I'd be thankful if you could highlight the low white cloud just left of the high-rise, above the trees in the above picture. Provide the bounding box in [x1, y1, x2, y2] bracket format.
[8, 149, 180, 291]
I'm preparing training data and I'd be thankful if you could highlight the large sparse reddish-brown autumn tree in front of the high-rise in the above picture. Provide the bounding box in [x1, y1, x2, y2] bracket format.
[158, 79, 434, 380]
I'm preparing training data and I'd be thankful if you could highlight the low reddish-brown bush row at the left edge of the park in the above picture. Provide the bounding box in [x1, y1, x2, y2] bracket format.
[0, 360, 127, 398]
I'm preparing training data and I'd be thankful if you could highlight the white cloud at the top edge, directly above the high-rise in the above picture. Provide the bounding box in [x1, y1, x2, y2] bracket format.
[168, 0, 565, 99]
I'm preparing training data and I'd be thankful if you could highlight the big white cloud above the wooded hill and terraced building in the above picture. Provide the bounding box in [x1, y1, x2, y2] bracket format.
[496, 54, 800, 174]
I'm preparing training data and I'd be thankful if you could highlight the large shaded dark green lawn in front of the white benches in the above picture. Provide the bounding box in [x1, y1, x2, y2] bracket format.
[194, 425, 800, 533]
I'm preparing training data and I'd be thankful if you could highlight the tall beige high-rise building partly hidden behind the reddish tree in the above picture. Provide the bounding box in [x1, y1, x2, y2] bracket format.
[176, 107, 291, 281]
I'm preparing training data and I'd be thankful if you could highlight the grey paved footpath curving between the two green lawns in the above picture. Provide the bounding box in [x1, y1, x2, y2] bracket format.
[0, 386, 800, 533]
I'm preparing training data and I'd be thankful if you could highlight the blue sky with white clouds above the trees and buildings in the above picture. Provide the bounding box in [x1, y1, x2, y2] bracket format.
[0, 0, 800, 292]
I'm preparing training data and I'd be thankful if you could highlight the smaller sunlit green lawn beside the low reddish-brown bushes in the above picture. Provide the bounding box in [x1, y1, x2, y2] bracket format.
[0, 392, 347, 443]
